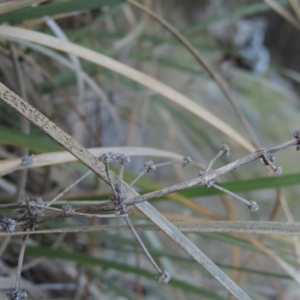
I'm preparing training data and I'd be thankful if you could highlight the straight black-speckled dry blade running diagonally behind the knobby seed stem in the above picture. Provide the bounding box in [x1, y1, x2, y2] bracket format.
[0, 83, 250, 300]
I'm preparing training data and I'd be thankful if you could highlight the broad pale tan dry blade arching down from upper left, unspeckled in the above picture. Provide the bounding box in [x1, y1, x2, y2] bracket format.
[0, 26, 255, 151]
